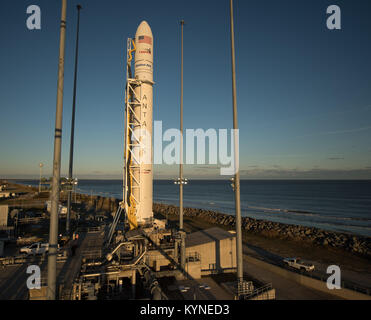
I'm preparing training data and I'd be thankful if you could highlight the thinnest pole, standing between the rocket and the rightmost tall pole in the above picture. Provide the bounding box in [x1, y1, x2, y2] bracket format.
[179, 20, 185, 270]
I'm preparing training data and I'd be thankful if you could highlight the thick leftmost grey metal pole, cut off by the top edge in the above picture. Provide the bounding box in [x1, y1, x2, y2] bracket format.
[47, 0, 67, 300]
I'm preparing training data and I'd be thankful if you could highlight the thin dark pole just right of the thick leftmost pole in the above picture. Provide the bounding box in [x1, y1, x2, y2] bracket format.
[66, 4, 81, 234]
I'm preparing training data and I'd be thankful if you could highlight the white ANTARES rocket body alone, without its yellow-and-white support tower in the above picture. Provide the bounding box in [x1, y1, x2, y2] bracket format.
[132, 21, 153, 225]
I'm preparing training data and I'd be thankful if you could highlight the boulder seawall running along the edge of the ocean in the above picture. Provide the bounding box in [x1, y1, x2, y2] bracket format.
[0, 182, 371, 259]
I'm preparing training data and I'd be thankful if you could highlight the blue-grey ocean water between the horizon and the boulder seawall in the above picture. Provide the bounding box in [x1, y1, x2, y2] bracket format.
[17, 180, 371, 236]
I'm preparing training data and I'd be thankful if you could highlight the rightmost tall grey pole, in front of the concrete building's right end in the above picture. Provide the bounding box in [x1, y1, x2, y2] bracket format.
[230, 0, 243, 283]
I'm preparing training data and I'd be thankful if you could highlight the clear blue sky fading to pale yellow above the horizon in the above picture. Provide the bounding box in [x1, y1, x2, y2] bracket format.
[0, 0, 371, 179]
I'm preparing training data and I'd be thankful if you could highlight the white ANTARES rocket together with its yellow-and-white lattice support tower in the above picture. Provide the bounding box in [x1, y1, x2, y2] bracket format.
[123, 21, 154, 229]
